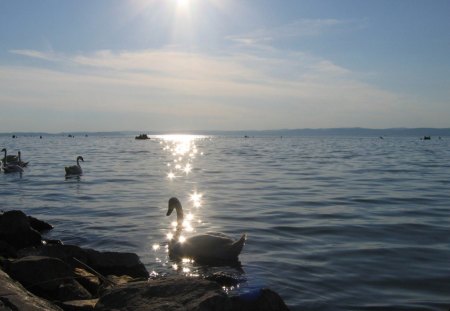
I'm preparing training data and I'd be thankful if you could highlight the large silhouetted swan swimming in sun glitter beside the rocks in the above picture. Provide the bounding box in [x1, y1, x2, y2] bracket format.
[166, 198, 247, 262]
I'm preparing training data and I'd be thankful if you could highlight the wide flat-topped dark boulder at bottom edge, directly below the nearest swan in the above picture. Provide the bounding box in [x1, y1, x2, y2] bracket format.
[94, 277, 231, 311]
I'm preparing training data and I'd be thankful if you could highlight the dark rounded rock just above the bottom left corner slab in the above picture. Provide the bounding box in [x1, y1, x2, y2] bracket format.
[7, 256, 91, 301]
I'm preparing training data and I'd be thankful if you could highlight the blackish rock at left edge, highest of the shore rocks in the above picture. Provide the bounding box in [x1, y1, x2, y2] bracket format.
[0, 211, 42, 250]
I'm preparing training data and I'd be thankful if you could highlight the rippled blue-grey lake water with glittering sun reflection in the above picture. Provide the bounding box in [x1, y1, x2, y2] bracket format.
[0, 136, 450, 310]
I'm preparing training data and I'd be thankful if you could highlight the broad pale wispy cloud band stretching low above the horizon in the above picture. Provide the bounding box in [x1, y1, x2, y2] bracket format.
[0, 43, 430, 130]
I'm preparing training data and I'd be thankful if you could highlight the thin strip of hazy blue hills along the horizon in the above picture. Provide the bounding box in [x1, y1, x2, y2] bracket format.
[0, 128, 450, 137]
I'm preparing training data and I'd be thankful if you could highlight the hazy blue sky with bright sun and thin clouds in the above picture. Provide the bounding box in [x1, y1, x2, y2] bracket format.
[0, 0, 450, 133]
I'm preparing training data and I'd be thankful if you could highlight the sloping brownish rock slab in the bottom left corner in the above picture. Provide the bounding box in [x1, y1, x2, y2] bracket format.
[0, 270, 62, 311]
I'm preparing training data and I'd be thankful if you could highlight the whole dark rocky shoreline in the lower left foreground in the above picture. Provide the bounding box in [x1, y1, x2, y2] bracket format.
[0, 210, 288, 311]
